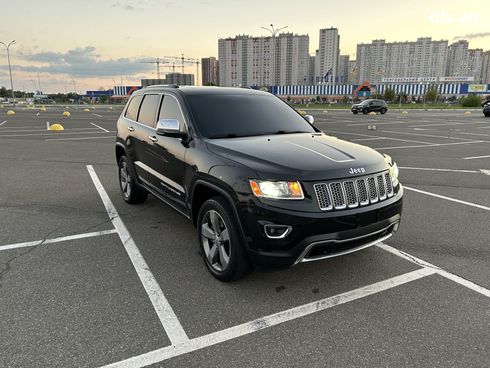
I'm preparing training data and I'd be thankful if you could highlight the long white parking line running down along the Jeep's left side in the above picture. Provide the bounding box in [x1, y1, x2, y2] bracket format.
[87, 165, 189, 345]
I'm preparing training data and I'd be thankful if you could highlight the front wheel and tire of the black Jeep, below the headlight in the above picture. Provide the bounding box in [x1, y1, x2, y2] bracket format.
[197, 197, 252, 282]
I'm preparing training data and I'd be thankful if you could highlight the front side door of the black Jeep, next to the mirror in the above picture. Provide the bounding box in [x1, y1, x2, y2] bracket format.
[148, 94, 187, 213]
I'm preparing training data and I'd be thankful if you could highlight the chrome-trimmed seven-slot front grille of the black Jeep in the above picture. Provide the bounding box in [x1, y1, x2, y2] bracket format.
[313, 171, 394, 211]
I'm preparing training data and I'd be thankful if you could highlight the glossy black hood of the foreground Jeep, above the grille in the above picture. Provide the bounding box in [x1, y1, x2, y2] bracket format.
[207, 133, 387, 181]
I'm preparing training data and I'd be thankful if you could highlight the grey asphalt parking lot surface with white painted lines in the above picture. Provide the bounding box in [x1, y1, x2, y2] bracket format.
[0, 106, 490, 367]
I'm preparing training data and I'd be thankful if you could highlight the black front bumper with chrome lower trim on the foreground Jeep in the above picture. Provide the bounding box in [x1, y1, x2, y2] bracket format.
[240, 185, 403, 268]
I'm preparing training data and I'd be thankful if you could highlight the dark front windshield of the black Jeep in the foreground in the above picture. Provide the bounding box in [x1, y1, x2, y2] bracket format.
[187, 94, 315, 138]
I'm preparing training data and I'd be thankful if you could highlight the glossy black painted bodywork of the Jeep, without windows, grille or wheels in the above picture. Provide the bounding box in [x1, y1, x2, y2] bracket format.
[116, 87, 403, 268]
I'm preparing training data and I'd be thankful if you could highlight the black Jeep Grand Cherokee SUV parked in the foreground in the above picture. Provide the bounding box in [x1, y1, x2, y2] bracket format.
[116, 86, 403, 281]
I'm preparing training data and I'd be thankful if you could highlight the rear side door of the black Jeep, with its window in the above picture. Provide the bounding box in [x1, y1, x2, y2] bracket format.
[132, 94, 161, 186]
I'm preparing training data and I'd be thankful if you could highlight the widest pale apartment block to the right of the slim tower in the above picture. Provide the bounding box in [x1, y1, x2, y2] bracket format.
[356, 37, 448, 83]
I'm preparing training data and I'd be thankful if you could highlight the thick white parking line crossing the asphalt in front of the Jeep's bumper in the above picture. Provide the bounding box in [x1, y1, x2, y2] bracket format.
[98, 267, 436, 368]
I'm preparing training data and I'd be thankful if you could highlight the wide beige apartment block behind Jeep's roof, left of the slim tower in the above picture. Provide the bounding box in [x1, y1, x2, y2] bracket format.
[218, 33, 310, 87]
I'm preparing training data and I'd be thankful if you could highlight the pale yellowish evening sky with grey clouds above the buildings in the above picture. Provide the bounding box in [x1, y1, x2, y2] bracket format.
[0, 0, 490, 93]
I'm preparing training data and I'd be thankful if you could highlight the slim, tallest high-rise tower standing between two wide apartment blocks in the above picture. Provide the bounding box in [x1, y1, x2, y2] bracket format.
[318, 27, 340, 83]
